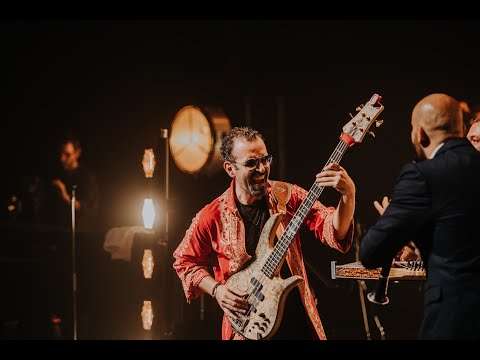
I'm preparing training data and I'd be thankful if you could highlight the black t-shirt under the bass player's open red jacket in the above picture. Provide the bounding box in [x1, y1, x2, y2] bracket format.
[236, 198, 318, 340]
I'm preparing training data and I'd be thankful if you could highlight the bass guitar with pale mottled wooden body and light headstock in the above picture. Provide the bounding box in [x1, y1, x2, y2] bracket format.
[226, 94, 384, 340]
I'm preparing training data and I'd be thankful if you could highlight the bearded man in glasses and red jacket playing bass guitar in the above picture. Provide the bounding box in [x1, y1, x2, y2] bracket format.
[173, 127, 355, 340]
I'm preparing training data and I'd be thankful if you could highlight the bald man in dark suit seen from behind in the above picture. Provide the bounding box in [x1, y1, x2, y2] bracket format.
[360, 93, 480, 340]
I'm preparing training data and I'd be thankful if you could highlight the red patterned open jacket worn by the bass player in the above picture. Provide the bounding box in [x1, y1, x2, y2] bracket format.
[173, 180, 353, 340]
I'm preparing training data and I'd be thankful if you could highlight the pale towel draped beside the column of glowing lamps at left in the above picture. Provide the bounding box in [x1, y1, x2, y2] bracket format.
[103, 226, 148, 261]
